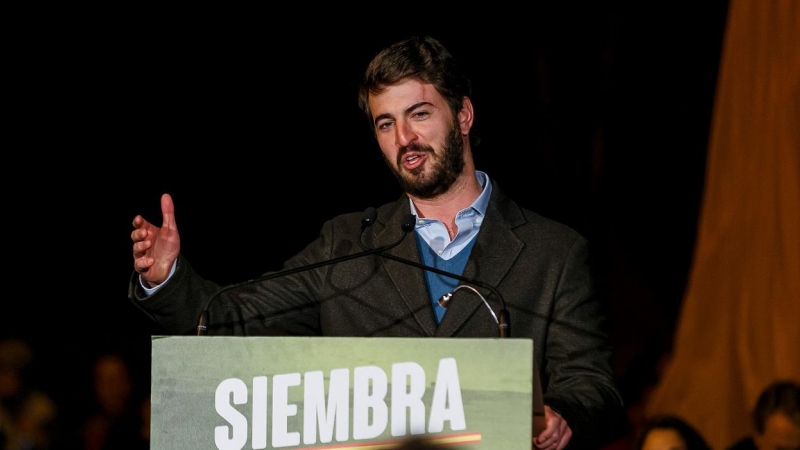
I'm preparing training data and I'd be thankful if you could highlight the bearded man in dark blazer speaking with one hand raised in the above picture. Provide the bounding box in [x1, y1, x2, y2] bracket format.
[130, 37, 621, 449]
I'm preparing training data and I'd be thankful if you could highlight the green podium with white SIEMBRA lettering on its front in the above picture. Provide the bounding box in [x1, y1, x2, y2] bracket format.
[150, 336, 541, 450]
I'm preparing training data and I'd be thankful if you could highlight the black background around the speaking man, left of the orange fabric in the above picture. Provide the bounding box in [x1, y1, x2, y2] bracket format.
[0, 1, 727, 432]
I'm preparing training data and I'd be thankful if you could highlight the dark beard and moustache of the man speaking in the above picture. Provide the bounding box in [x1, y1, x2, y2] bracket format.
[383, 118, 464, 199]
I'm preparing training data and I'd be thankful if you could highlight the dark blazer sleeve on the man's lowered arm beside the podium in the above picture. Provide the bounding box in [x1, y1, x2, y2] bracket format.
[542, 237, 624, 449]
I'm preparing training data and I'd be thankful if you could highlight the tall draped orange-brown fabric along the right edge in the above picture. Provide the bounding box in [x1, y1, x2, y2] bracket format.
[647, 0, 800, 449]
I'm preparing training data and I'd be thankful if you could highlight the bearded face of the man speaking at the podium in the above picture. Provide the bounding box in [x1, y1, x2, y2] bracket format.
[369, 80, 466, 198]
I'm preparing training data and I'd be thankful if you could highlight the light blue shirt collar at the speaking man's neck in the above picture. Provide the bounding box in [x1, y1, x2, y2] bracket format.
[409, 170, 492, 260]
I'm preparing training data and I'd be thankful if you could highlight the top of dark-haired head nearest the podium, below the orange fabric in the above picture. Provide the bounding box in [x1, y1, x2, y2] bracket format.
[634, 415, 711, 450]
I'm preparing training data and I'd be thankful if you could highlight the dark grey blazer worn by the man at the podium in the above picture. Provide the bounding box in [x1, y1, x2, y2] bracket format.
[129, 182, 622, 449]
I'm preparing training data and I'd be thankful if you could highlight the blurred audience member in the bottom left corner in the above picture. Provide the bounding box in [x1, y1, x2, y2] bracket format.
[0, 338, 58, 450]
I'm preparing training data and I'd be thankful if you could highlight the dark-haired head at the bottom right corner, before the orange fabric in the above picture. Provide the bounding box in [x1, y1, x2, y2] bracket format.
[753, 380, 800, 450]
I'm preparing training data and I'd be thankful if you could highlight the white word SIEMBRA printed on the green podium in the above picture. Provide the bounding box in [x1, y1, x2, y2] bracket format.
[214, 358, 467, 450]
